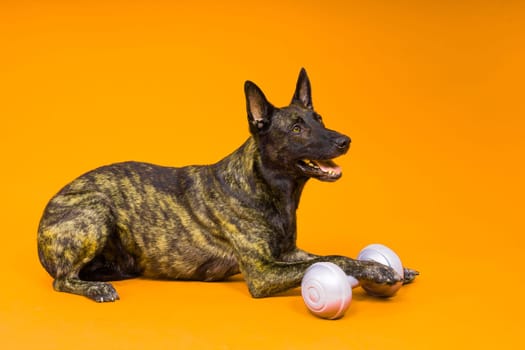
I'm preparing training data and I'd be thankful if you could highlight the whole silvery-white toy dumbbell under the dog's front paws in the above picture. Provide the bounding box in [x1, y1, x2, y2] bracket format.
[301, 244, 404, 320]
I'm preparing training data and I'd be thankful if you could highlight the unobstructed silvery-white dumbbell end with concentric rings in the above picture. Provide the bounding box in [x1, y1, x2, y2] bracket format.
[301, 262, 352, 320]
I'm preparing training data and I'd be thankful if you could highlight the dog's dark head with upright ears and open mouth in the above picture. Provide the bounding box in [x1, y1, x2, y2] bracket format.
[244, 68, 350, 181]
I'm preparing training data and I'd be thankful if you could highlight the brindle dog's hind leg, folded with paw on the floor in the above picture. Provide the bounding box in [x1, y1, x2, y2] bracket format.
[38, 193, 119, 302]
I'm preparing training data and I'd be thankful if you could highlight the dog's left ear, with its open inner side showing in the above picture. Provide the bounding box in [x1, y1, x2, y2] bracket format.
[244, 81, 275, 133]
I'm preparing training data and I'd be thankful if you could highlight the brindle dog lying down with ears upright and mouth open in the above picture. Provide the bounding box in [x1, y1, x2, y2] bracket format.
[37, 68, 417, 302]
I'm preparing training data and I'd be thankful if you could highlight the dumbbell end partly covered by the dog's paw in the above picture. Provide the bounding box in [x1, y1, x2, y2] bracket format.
[357, 244, 404, 297]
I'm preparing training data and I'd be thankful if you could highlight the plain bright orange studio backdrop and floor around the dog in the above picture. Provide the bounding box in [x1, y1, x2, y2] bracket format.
[0, 0, 525, 349]
